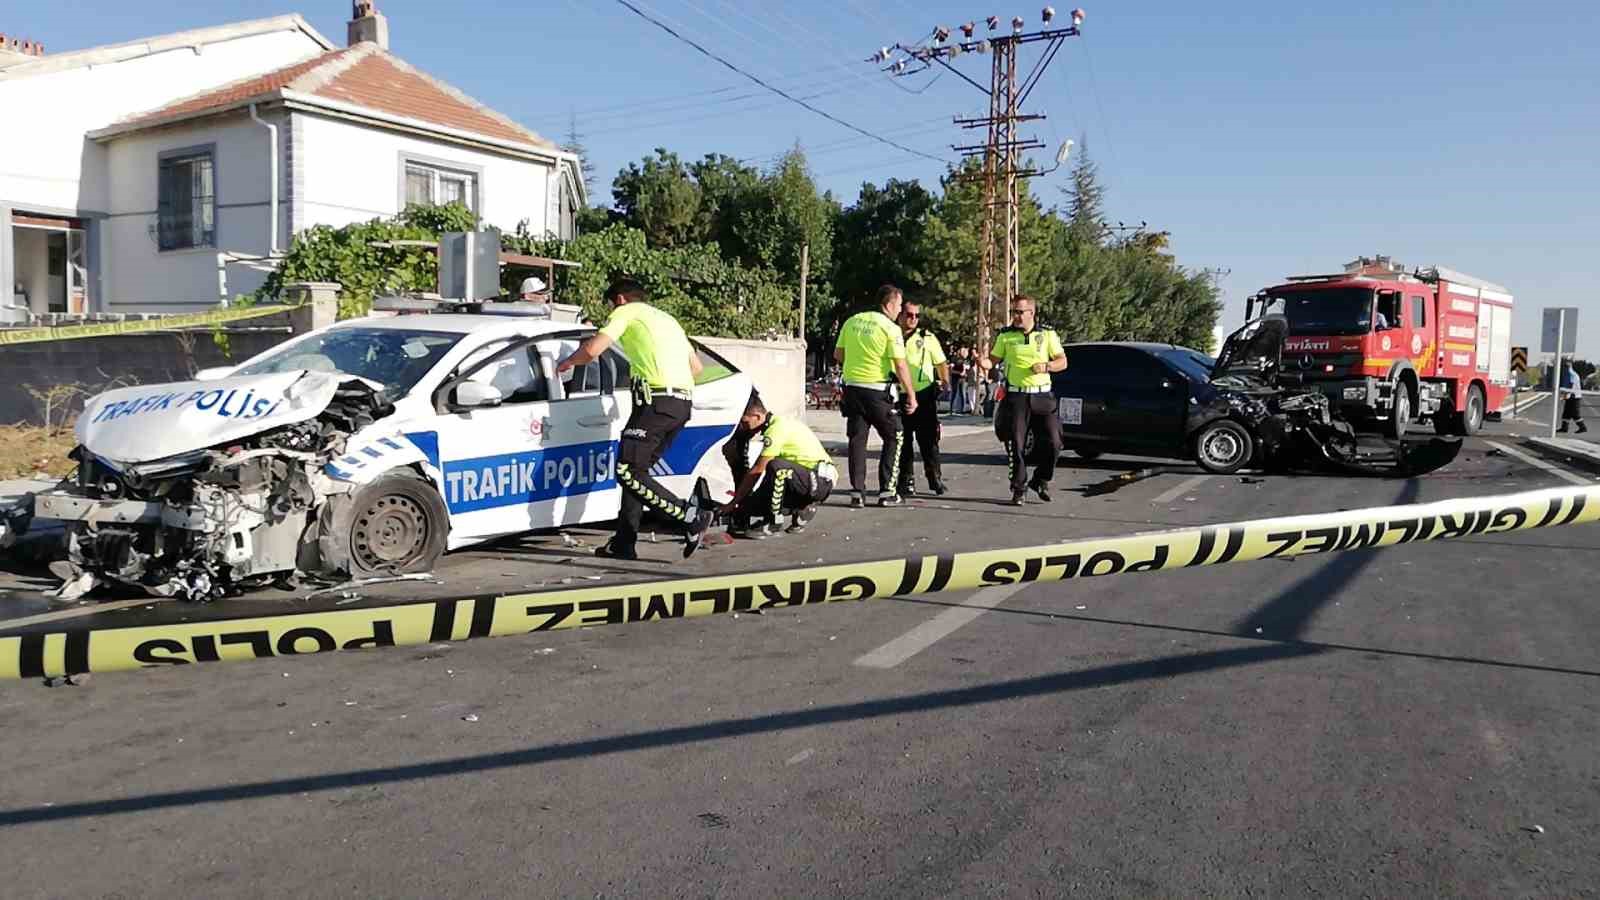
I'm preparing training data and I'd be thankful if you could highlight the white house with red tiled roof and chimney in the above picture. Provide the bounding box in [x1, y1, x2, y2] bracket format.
[0, 0, 586, 322]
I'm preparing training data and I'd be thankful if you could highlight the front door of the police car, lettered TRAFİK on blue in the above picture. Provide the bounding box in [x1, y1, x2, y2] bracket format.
[434, 331, 594, 534]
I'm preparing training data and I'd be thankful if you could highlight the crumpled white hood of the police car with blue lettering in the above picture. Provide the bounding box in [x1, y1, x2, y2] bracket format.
[77, 370, 352, 464]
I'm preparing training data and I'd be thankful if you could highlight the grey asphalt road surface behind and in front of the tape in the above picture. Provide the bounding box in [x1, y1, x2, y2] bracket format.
[0, 423, 1600, 897]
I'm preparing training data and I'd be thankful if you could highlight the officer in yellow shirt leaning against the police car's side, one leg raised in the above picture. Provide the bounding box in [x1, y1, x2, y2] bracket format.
[555, 279, 714, 559]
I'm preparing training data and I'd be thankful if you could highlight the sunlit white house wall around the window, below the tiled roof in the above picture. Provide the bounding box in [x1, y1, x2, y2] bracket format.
[294, 112, 555, 234]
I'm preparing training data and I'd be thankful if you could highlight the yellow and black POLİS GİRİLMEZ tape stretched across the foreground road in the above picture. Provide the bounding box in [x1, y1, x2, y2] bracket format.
[0, 485, 1600, 679]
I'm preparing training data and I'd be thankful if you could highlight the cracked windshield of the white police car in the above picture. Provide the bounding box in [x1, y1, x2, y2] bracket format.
[234, 328, 461, 400]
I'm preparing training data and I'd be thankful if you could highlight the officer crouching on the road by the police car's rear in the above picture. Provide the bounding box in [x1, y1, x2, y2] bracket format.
[718, 396, 838, 540]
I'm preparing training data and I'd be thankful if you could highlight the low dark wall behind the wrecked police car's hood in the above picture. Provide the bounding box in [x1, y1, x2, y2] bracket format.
[0, 314, 290, 424]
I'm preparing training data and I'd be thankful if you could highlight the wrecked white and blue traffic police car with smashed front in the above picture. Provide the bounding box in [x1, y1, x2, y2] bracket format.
[13, 314, 750, 601]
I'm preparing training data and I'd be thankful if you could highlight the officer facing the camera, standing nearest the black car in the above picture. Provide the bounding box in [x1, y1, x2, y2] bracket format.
[979, 295, 1067, 506]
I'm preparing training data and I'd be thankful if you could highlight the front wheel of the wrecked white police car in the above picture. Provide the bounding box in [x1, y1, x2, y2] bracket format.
[331, 472, 450, 578]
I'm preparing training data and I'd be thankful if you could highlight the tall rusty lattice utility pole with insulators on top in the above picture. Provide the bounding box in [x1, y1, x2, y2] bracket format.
[872, 6, 1083, 348]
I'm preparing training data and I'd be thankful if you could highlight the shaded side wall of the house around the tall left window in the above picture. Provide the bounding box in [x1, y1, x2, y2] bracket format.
[101, 114, 276, 312]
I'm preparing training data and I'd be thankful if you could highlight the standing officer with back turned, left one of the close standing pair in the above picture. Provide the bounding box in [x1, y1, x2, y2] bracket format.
[834, 285, 917, 508]
